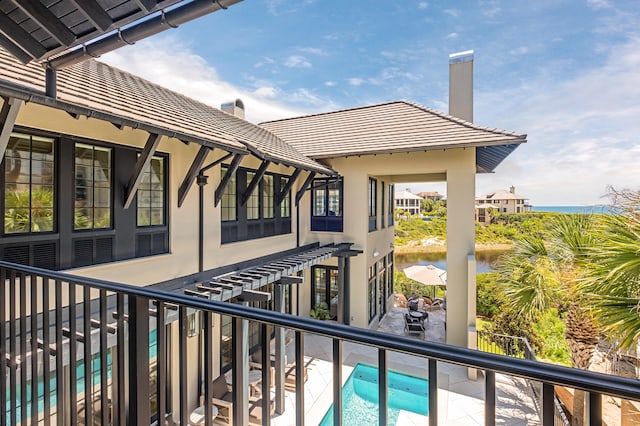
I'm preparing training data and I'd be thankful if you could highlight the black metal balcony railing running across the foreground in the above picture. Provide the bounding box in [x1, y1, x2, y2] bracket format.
[0, 262, 640, 425]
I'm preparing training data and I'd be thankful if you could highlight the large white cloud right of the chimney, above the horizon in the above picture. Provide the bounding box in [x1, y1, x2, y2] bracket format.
[476, 35, 640, 205]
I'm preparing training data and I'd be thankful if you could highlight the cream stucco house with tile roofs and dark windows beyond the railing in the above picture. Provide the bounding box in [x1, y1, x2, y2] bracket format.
[0, 50, 526, 420]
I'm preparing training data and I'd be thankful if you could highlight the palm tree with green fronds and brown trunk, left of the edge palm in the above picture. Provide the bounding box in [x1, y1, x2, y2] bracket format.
[498, 215, 598, 424]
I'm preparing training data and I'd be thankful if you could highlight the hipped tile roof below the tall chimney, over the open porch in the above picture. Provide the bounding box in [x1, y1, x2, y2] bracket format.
[260, 101, 526, 171]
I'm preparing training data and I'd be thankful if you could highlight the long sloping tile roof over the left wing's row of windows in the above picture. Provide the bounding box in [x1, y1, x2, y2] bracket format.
[0, 49, 334, 174]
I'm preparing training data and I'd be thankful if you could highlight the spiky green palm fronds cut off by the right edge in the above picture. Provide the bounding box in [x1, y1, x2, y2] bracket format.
[583, 188, 640, 349]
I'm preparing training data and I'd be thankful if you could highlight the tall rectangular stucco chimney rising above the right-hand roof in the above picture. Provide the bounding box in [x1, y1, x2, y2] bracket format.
[449, 50, 473, 122]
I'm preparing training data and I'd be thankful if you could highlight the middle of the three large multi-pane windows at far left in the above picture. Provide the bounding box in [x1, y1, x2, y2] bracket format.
[73, 143, 112, 230]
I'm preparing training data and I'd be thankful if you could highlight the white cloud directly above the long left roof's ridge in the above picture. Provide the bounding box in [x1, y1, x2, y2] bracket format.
[100, 35, 336, 123]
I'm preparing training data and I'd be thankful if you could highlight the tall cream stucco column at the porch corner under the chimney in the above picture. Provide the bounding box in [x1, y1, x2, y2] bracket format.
[447, 148, 476, 347]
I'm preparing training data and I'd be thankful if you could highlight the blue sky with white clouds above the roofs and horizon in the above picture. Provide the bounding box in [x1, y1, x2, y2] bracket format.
[102, 0, 640, 205]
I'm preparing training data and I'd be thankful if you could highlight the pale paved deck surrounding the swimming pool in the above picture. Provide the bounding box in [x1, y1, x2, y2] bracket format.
[271, 308, 540, 426]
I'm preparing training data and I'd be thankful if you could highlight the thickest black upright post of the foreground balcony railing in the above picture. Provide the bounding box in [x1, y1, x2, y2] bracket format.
[129, 295, 151, 425]
